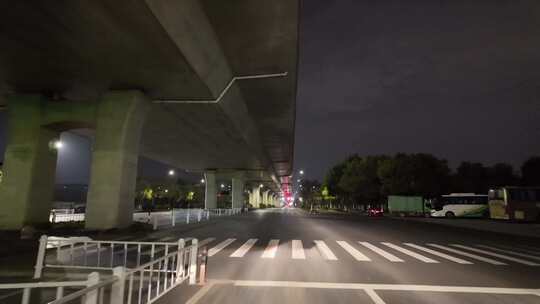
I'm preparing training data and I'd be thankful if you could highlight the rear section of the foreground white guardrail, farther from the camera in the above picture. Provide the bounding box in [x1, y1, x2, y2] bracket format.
[34, 235, 196, 279]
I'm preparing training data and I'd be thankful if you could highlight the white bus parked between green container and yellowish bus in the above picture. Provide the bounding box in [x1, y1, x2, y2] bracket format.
[431, 193, 489, 218]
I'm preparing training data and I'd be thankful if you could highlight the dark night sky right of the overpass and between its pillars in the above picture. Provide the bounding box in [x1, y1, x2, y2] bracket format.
[0, 0, 540, 183]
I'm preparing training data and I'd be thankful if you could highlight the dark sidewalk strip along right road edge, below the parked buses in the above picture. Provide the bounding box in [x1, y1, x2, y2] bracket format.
[392, 217, 540, 238]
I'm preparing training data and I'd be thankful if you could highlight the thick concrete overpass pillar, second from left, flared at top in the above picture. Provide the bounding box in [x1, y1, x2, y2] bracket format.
[86, 90, 149, 230]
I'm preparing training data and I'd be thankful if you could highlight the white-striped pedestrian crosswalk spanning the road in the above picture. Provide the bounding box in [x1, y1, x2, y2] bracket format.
[191, 237, 540, 267]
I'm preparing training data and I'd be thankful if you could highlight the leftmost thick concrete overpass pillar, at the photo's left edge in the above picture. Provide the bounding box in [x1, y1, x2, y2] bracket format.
[0, 95, 59, 229]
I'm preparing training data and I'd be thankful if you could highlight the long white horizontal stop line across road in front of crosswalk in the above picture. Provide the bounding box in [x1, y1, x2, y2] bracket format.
[232, 280, 540, 296]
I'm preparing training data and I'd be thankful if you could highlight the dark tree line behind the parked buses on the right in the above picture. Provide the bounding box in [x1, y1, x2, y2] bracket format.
[324, 153, 540, 205]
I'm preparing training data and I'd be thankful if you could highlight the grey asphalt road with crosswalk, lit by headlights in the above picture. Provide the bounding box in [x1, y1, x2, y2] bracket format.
[155, 209, 540, 303]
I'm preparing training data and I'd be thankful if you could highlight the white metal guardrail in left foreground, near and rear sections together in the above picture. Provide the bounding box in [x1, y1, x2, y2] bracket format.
[0, 236, 198, 304]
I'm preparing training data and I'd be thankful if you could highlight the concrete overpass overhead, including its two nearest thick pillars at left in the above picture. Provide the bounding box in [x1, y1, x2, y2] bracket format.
[0, 0, 299, 228]
